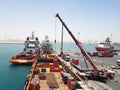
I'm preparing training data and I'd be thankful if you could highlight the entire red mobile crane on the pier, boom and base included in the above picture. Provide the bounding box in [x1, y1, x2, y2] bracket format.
[56, 13, 115, 78]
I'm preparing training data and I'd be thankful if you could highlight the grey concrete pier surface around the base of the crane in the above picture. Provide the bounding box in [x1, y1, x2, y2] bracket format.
[61, 52, 120, 90]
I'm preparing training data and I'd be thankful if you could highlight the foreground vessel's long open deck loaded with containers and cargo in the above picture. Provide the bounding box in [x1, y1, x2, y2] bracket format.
[25, 55, 91, 90]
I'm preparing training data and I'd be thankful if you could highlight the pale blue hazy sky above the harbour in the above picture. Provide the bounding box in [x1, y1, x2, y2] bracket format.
[0, 0, 120, 42]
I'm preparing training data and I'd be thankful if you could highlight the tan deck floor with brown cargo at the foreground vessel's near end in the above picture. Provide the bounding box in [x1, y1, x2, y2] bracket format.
[35, 72, 69, 90]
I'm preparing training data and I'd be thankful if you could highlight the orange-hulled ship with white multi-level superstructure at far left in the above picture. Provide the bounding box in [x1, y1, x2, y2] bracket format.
[9, 32, 40, 64]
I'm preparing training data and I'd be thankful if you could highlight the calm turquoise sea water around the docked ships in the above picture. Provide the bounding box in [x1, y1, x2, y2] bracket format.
[0, 43, 120, 90]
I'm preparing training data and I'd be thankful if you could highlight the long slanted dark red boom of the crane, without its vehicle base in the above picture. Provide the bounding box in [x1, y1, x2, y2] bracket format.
[56, 14, 100, 76]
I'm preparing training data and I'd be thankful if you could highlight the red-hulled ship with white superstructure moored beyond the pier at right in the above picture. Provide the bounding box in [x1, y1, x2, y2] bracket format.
[95, 37, 114, 51]
